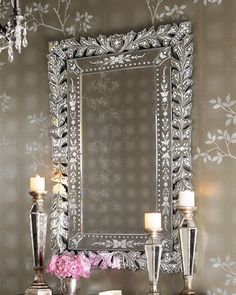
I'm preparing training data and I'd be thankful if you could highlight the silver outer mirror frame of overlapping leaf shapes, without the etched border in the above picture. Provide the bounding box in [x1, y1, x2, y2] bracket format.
[48, 22, 193, 273]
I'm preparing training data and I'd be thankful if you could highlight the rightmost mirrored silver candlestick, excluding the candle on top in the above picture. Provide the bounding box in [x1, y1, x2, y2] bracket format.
[179, 206, 197, 294]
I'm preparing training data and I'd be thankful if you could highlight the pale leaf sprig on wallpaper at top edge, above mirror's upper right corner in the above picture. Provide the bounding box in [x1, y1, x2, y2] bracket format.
[146, 0, 186, 25]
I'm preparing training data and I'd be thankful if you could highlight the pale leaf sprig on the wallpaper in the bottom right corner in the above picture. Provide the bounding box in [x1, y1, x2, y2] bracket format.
[207, 254, 236, 295]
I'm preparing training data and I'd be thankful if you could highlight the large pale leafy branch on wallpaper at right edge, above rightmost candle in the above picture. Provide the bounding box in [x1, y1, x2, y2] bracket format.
[194, 94, 236, 164]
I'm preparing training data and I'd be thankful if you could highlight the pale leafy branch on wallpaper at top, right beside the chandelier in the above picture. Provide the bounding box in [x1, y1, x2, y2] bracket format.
[25, 0, 93, 37]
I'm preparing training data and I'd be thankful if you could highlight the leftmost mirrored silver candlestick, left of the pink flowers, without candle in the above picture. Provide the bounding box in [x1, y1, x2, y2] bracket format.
[25, 192, 52, 295]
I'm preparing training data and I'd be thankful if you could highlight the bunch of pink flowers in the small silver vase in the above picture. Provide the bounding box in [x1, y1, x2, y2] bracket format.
[46, 253, 91, 279]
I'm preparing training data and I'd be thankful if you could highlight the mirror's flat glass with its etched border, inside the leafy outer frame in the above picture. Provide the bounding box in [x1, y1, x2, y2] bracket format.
[68, 48, 172, 250]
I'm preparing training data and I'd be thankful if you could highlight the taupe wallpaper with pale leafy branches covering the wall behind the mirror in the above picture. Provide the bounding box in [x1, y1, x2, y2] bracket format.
[0, 0, 236, 295]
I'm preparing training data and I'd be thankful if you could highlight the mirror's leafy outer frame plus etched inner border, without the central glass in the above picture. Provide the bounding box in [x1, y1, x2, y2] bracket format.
[49, 22, 192, 272]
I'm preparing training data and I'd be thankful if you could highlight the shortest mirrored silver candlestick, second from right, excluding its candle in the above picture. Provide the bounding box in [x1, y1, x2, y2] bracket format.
[145, 229, 162, 295]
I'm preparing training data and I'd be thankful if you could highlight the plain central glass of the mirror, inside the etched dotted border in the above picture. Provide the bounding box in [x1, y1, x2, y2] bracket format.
[81, 68, 156, 236]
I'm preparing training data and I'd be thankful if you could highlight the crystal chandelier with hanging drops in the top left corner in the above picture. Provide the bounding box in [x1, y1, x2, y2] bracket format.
[0, 0, 27, 62]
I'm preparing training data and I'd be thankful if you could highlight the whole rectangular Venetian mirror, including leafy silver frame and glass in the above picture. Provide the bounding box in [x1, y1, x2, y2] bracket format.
[49, 22, 192, 272]
